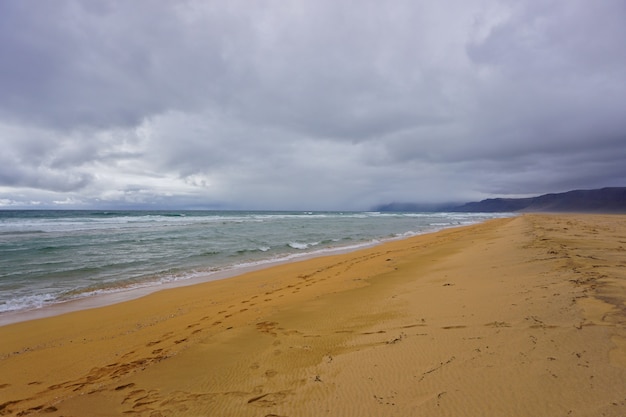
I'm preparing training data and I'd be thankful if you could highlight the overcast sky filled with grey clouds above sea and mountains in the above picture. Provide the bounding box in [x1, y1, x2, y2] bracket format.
[0, 0, 626, 210]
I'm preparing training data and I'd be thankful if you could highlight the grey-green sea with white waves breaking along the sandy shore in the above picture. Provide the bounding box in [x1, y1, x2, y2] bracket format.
[0, 210, 503, 317]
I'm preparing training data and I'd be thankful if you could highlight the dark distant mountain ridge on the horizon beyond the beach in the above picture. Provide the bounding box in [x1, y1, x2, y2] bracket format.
[377, 187, 626, 213]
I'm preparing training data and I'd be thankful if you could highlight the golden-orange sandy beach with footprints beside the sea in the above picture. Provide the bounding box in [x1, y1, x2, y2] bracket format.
[0, 214, 626, 417]
